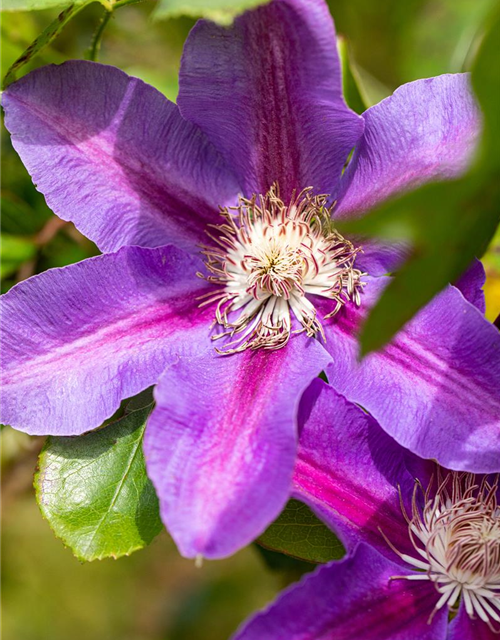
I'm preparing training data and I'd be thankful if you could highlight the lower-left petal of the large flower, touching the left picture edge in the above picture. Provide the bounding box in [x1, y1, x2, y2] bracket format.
[0, 247, 213, 435]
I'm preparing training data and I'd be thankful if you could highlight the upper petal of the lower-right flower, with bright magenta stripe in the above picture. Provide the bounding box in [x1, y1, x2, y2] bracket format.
[293, 380, 414, 561]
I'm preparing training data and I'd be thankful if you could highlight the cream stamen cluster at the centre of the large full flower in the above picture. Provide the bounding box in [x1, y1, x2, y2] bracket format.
[198, 185, 366, 354]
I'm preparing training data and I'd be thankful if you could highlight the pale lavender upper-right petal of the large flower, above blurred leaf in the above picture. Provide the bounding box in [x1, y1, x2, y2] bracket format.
[335, 74, 481, 218]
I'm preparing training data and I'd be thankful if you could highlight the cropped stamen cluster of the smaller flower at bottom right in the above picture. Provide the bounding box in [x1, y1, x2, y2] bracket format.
[390, 473, 500, 630]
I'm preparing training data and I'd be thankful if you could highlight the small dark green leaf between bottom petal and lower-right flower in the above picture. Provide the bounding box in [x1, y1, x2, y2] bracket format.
[257, 500, 344, 563]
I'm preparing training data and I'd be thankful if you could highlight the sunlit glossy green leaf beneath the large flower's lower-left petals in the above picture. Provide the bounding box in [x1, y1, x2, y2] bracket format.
[35, 401, 162, 561]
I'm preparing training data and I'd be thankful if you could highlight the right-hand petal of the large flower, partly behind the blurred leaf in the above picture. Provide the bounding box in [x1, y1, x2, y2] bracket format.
[317, 278, 500, 473]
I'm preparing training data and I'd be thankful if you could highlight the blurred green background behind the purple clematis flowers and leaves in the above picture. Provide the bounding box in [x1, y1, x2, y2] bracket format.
[0, 0, 500, 640]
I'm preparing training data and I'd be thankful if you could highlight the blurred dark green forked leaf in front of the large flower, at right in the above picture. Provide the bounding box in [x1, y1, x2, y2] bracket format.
[339, 5, 500, 355]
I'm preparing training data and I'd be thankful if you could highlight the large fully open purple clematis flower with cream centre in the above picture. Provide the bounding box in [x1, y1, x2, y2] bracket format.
[0, 0, 500, 558]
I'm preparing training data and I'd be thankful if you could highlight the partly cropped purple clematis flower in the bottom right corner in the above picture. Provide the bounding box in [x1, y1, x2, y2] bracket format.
[235, 380, 500, 640]
